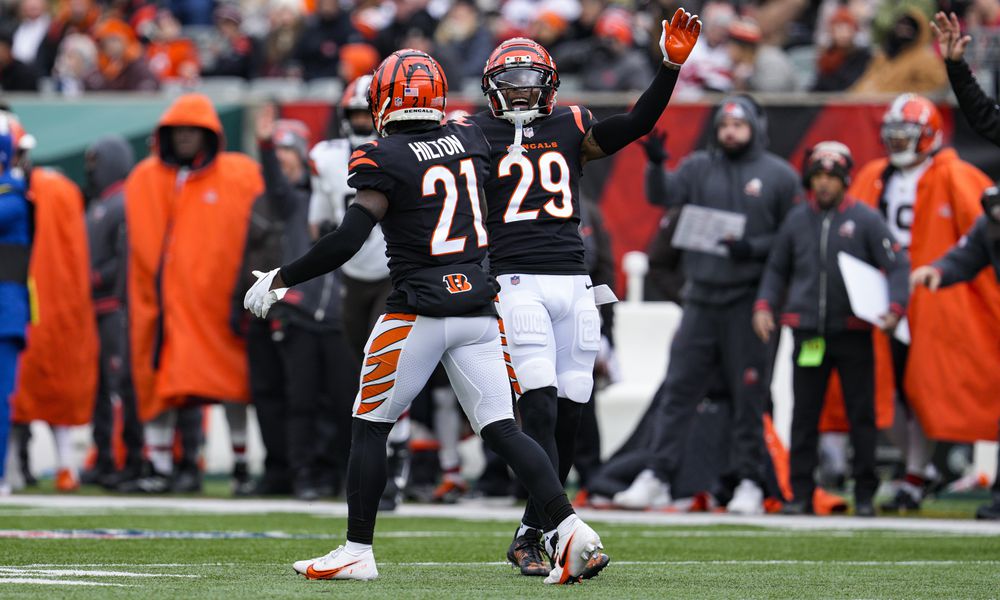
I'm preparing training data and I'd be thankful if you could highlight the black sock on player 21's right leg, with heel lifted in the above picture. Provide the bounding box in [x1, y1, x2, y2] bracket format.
[480, 419, 575, 529]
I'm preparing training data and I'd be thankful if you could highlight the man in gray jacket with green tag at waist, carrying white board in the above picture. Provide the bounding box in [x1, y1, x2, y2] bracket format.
[753, 142, 910, 517]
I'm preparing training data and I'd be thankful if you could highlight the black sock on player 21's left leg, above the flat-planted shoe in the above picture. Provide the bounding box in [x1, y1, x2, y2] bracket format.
[347, 418, 392, 545]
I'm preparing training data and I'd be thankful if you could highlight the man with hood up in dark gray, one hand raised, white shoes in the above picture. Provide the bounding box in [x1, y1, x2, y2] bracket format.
[614, 95, 801, 514]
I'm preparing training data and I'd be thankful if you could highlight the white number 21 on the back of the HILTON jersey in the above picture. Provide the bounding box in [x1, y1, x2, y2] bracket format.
[422, 158, 487, 256]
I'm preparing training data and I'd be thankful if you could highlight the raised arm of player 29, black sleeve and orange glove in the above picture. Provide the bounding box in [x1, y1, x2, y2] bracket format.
[581, 8, 701, 162]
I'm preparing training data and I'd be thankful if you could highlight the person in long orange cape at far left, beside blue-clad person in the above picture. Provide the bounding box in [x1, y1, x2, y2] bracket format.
[12, 113, 98, 492]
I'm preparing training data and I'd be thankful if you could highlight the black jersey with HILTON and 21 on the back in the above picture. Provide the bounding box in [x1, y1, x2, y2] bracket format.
[348, 123, 489, 289]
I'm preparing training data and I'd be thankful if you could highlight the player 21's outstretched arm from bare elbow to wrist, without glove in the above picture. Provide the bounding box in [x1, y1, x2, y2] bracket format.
[271, 190, 389, 289]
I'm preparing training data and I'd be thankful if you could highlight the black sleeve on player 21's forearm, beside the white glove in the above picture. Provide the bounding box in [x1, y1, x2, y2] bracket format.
[280, 204, 378, 287]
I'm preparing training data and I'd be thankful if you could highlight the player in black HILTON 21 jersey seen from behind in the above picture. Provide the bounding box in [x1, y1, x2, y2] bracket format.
[244, 50, 608, 584]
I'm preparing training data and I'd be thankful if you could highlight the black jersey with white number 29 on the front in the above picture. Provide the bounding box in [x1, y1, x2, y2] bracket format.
[471, 106, 594, 275]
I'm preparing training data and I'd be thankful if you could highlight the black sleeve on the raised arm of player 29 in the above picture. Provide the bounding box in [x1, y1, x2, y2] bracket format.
[591, 65, 680, 154]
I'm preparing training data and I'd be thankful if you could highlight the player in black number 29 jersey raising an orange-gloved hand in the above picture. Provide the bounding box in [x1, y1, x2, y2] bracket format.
[471, 9, 701, 575]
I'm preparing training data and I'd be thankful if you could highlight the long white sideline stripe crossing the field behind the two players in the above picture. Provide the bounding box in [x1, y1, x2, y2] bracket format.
[0, 495, 1000, 535]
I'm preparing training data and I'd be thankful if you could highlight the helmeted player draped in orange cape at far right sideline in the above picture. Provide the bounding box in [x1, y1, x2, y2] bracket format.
[848, 94, 1000, 511]
